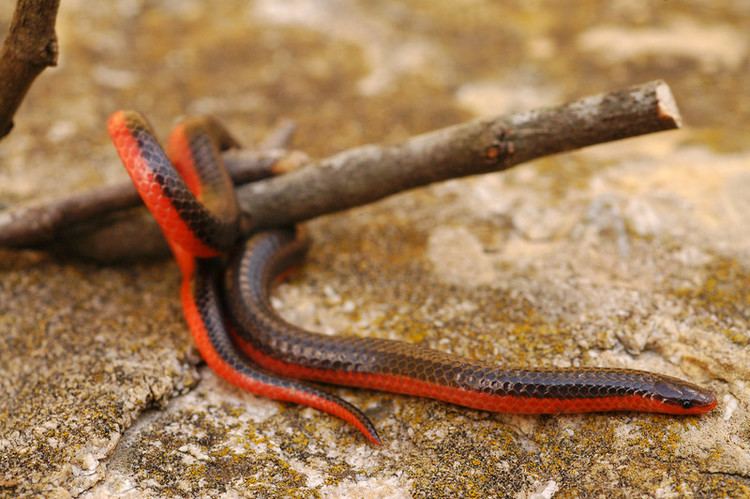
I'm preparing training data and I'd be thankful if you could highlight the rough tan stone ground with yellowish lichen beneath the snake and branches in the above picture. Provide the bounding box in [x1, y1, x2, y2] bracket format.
[0, 0, 750, 498]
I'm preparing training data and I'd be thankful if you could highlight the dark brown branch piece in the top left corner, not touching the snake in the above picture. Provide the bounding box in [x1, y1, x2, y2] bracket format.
[0, 0, 60, 139]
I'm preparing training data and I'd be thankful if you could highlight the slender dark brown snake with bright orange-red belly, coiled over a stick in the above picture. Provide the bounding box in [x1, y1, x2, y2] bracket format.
[107, 110, 717, 445]
